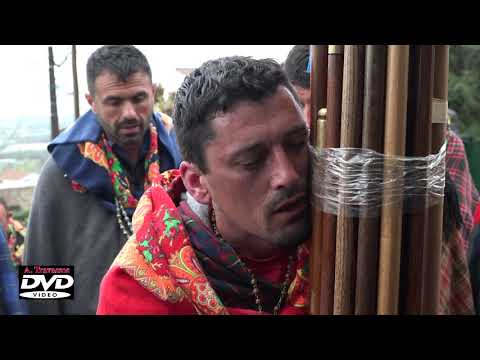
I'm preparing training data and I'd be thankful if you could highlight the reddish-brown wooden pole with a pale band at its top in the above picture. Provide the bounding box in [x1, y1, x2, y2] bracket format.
[320, 45, 344, 315]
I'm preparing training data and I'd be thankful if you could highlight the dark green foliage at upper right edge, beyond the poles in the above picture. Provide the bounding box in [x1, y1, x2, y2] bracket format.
[448, 45, 480, 140]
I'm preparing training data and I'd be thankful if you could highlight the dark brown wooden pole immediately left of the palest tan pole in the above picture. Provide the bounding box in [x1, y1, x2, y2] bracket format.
[355, 45, 387, 315]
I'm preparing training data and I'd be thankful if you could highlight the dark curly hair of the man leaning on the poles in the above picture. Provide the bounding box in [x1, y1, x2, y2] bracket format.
[173, 56, 298, 173]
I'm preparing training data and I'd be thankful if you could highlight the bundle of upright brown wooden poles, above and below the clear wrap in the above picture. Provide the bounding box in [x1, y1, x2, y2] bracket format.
[309, 45, 448, 315]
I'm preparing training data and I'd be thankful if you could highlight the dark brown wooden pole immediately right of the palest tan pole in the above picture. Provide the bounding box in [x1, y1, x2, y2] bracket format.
[400, 45, 433, 315]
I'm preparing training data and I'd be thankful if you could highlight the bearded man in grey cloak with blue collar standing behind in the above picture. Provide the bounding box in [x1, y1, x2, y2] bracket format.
[25, 45, 180, 314]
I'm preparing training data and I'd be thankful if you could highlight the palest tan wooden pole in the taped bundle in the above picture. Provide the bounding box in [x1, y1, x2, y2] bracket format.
[377, 45, 409, 315]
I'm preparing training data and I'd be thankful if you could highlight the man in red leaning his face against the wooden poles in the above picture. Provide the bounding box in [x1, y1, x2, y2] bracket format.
[97, 57, 310, 315]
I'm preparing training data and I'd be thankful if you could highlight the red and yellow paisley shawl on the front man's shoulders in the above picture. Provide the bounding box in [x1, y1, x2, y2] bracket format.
[112, 171, 308, 315]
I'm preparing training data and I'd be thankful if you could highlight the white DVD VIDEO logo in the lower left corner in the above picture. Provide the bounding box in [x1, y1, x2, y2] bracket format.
[19, 268, 74, 300]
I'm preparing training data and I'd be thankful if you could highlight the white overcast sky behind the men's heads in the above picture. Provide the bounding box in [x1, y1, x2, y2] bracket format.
[0, 45, 293, 128]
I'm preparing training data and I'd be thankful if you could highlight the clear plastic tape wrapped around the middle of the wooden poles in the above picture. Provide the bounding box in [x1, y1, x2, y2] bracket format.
[310, 143, 447, 217]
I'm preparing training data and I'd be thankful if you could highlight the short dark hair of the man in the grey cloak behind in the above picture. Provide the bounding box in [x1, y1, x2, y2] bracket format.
[87, 45, 152, 95]
